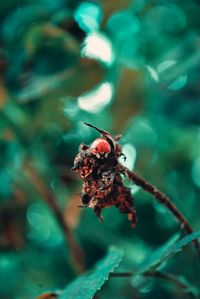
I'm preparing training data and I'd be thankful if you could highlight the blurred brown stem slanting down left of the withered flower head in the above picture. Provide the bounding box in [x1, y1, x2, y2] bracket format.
[24, 163, 84, 273]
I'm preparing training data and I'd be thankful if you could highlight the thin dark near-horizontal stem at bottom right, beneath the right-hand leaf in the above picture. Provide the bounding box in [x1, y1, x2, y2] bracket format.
[110, 271, 194, 298]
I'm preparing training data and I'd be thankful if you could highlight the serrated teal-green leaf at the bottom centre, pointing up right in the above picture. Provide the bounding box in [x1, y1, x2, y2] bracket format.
[58, 247, 123, 299]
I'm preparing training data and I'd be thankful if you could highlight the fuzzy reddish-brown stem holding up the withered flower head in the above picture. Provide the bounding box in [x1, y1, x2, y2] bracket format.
[120, 164, 200, 255]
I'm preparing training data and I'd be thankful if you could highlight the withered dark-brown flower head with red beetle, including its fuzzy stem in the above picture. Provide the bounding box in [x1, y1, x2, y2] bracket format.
[72, 122, 200, 252]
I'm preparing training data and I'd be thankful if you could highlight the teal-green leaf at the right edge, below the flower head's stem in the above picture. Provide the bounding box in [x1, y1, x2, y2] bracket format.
[139, 231, 200, 274]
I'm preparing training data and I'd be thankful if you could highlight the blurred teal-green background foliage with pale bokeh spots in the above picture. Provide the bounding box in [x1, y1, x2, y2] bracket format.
[0, 0, 200, 299]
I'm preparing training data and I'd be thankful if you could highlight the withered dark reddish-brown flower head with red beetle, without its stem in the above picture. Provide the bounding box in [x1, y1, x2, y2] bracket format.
[73, 123, 137, 227]
